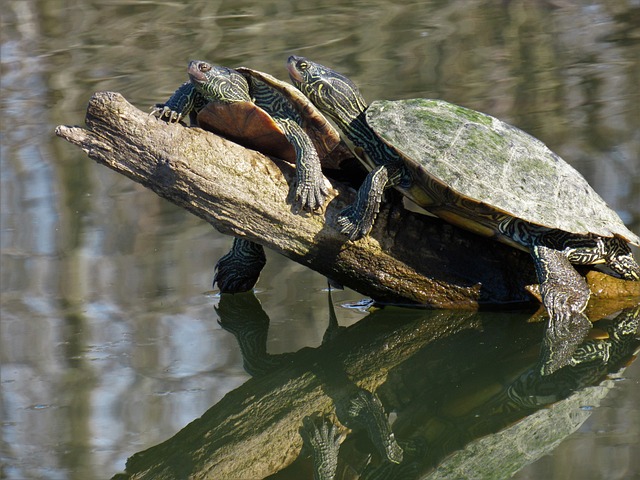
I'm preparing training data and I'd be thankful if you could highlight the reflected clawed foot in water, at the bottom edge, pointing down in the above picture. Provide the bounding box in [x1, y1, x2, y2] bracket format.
[300, 417, 343, 480]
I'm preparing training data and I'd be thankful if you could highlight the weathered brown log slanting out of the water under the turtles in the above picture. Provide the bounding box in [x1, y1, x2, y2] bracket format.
[56, 92, 640, 308]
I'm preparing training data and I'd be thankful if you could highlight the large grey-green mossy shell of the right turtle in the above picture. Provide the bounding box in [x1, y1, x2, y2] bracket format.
[366, 99, 640, 245]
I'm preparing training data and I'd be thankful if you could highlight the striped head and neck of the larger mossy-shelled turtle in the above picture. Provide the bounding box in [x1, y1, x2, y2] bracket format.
[287, 55, 367, 125]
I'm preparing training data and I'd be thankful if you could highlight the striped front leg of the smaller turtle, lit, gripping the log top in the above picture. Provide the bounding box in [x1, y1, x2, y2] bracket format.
[275, 119, 329, 211]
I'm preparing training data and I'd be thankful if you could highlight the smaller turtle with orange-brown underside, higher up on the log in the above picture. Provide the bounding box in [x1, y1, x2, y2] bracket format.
[151, 60, 353, 293]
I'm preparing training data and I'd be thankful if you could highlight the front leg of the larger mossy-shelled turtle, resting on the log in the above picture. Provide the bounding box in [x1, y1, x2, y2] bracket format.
[337, 165, 390, 241]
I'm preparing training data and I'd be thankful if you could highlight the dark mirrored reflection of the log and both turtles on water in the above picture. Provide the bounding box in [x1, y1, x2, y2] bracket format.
[114, 292, 640, 479]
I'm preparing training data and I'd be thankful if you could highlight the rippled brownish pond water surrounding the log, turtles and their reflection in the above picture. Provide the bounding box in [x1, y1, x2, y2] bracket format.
[0, 0, 640, 479]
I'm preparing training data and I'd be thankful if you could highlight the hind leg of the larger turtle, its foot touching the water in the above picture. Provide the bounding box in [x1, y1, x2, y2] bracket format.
[531, 245, 591, 334]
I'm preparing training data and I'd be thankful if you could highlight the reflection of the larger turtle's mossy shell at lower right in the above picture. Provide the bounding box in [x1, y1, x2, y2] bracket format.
[424, 307, 640, 478]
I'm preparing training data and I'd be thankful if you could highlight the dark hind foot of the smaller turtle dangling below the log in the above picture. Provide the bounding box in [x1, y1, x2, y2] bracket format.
[213, 238, 267, 293]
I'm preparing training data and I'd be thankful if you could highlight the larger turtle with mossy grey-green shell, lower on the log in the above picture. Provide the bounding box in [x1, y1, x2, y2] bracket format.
[287, 55, 640, 320]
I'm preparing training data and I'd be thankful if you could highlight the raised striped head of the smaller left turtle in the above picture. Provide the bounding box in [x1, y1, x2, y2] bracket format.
[187, 60, 251, 103]
